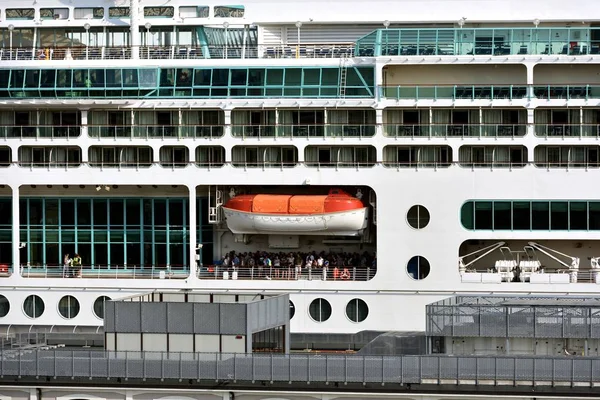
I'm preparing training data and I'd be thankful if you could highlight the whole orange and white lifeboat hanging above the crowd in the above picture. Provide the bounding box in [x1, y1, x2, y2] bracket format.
[223, 189, 368, 236]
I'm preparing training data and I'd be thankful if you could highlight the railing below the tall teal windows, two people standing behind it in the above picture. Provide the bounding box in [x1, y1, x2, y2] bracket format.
[21, 265, 190, 279]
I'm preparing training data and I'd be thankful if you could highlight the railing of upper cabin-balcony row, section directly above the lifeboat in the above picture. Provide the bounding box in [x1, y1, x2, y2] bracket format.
[231, 124, 375, 139]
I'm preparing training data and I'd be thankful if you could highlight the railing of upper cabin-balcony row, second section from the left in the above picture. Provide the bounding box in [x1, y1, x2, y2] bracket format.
[88, 125, 224, 139]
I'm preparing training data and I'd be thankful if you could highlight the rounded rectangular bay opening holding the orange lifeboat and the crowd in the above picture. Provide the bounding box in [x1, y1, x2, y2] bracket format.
[204, 185, 377, 281]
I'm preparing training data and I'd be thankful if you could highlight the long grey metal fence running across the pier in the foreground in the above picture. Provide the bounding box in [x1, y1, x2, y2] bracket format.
[0, 350, 600, 386]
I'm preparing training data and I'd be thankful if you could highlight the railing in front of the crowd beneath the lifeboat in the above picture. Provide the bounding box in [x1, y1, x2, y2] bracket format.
[198, 265, 377, 281]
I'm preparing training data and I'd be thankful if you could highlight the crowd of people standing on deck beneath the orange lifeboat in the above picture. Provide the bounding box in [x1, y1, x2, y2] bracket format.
[208, 251, 377, 280]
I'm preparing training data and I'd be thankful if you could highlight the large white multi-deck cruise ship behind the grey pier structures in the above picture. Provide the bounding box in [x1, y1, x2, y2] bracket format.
[0, 0, 600, 335]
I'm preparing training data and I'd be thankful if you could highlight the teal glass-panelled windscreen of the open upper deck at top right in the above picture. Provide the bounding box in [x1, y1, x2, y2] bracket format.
[354, 27, 600, 57]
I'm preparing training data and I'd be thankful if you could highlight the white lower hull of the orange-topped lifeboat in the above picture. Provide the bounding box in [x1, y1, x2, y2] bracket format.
[223, 207, 368, 236]
